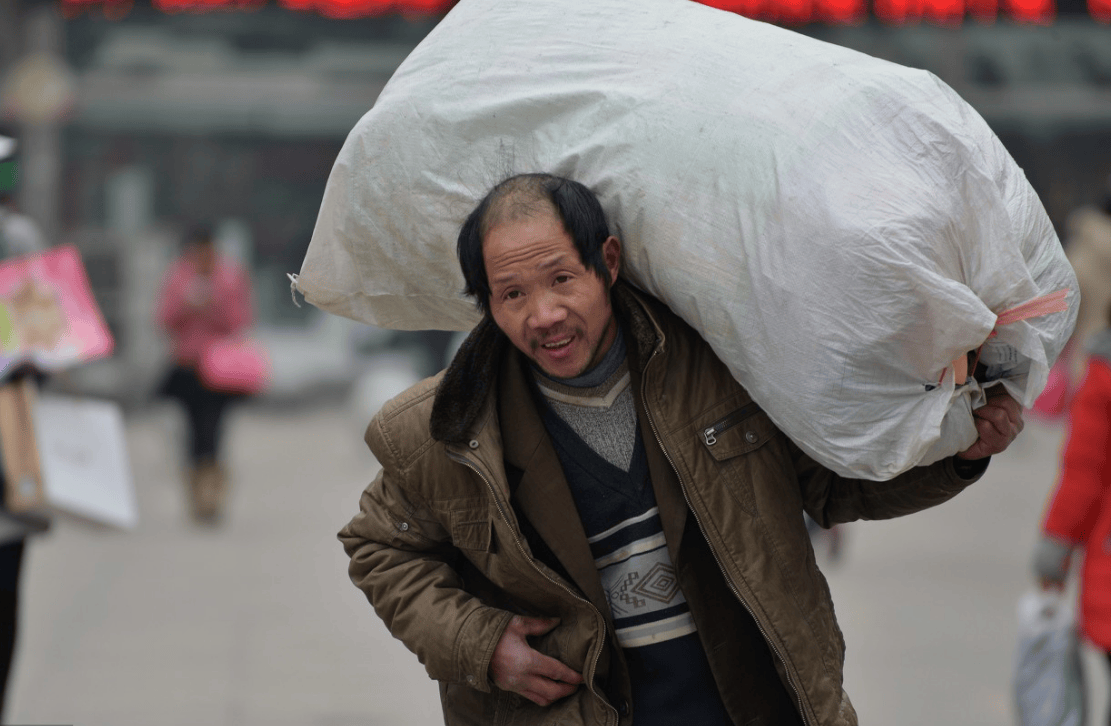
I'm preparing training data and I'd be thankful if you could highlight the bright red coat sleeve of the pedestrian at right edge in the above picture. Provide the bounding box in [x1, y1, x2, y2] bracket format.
[1042, 360, 1111, 545]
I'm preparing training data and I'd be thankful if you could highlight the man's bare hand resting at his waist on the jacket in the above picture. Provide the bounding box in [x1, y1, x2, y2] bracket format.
[490, 615, 582, 706]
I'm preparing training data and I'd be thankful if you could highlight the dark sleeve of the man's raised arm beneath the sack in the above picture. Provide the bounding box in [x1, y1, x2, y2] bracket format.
[790, 442, 985, 527]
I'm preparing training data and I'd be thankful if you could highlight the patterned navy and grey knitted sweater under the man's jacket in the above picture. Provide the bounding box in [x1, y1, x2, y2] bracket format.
[537, 336, 732, 726]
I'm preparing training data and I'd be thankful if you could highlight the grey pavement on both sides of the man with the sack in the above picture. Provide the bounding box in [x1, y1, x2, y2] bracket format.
[4, 406, 1093, 726]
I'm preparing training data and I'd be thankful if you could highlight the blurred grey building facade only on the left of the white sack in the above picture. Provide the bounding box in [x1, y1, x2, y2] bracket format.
[0, 0, 439, 402]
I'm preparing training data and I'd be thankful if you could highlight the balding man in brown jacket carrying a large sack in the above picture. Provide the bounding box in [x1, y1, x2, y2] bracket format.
[339, 173, 1022, 726]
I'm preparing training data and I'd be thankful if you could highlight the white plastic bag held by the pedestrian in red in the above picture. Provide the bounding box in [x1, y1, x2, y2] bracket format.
[1012, 590, 1087, 726]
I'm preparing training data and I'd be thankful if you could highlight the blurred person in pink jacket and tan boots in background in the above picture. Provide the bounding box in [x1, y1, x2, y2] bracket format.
[158, 226, 253, 520]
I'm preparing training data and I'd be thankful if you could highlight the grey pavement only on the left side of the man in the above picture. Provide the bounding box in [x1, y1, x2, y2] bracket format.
[4, 400, 442, 726]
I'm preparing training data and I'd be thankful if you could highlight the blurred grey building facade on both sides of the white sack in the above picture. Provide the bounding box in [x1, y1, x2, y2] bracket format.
[0, 0, 1111, 400]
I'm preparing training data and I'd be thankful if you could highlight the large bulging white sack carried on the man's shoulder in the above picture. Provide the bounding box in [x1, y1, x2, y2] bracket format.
[297, 0, 1077, 479]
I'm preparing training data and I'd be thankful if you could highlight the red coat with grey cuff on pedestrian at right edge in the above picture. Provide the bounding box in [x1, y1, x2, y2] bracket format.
[1032, 304, 1111, 720]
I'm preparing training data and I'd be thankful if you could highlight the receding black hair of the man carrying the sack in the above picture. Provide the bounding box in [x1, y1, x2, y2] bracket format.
[456, 173, 613, 314]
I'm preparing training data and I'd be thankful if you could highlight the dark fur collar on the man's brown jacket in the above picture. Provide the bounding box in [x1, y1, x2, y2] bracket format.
[430, 278, 659, 444]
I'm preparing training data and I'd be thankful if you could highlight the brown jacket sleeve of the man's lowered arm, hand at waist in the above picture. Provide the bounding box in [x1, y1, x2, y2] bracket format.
[339, 418, 512, 692]
